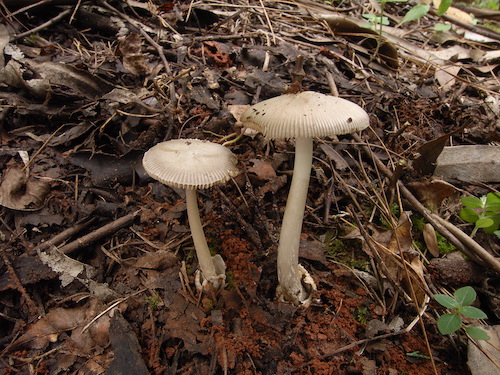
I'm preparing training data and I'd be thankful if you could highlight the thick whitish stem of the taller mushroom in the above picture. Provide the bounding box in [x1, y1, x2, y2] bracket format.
[278, 137, 313, 304]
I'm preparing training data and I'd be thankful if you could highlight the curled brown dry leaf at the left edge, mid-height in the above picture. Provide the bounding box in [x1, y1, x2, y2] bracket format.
[0, 168, 50, 211]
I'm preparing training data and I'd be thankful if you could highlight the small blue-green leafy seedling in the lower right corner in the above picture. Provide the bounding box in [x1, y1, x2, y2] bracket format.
[434, 286, 490, 340]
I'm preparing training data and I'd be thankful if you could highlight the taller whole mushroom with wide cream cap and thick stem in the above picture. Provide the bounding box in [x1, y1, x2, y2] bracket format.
[240, 91, 369, 305]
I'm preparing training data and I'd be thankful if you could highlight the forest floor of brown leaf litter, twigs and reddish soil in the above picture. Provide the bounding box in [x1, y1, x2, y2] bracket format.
[0, 0, 500, 375]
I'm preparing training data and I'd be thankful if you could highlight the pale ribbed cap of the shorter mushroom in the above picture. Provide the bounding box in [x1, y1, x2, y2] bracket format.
[142, 139, 239, 189]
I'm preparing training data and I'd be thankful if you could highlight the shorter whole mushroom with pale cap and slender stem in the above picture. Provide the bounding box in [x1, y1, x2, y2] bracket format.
[142, 139, 239, 289]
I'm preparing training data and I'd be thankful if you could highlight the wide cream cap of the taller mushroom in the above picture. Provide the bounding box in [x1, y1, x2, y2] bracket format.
[240, 91, 370, 139]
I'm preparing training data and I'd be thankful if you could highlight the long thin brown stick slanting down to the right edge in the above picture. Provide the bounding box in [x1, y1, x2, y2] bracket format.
[353, 134, 500, 273]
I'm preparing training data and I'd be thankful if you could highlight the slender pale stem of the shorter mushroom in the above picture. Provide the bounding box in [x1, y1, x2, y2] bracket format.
[186, 189, 218, 288]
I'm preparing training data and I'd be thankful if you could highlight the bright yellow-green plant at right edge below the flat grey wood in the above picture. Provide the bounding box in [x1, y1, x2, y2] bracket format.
[460, 193, 500, 237]
